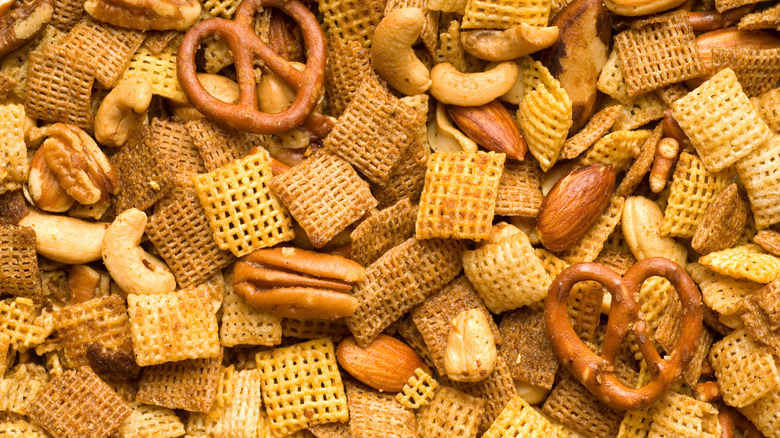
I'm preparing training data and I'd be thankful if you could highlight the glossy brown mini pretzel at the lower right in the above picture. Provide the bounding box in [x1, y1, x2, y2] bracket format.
[545, 257, 702, 410]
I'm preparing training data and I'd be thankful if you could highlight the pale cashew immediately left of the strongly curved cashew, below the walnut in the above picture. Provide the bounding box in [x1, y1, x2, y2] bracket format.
[19, 210, 108, 265]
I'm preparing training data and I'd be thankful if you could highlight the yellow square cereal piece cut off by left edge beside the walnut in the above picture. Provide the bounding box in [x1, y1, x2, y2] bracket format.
[0, 104, 29, 194]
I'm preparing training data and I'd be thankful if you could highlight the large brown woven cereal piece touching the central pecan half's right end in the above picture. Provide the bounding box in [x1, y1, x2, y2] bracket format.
[346, 238, 463, 347]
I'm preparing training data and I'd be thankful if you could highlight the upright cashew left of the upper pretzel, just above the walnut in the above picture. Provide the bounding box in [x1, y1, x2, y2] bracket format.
[95, 76, 152, 147]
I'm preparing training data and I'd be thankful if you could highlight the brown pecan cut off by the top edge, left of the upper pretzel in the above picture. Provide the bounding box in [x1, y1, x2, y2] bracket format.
[84, 0, 201, 30]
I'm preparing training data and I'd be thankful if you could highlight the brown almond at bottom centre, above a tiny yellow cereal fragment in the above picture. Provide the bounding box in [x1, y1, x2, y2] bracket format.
[336, 329, 432, 392]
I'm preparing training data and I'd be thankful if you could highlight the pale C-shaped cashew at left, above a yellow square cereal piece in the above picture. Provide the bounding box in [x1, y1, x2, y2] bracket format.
[103, 208, 176, 295]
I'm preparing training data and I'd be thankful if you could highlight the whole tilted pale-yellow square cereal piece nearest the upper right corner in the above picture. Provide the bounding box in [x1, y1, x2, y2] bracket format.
[672, 68, 771, 172]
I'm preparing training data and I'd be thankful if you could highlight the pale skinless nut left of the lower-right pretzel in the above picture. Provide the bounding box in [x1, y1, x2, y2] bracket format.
[444, 309, 498, 382]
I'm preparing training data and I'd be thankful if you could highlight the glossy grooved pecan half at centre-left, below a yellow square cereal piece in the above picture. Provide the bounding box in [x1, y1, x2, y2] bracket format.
[233, 247, 366, 319]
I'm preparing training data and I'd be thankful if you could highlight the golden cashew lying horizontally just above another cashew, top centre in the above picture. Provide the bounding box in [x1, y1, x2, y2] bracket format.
[460, 23, 558, 61]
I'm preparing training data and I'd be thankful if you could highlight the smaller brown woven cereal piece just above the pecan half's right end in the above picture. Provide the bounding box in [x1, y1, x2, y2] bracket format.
[350, 198, 417, 266]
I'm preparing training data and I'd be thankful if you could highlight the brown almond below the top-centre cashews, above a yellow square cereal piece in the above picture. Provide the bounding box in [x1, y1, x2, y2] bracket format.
[447, 100, 528, 160]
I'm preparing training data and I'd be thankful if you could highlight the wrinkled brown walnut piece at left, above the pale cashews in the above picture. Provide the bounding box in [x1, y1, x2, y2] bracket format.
[41, 123, 119, 205]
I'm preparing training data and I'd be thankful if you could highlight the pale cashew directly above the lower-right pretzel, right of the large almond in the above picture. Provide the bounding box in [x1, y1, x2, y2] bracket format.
[622, 196, 688, 267]
